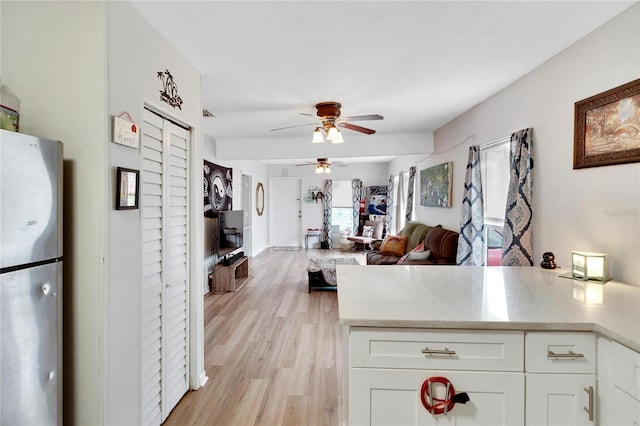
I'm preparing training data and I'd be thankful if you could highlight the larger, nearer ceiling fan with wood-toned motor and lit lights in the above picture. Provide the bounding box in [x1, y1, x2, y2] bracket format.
[271, 102, 384, 143]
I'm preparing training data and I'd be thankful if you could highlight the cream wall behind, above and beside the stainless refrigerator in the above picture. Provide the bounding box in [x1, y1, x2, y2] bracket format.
[0, 1, 107, 425]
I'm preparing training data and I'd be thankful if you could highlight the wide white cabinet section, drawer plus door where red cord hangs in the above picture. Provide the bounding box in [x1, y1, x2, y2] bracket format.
[345, 327, 524, 426]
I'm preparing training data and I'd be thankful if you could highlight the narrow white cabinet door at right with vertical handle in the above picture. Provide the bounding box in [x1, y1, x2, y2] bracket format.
[525, 374, 596, 426]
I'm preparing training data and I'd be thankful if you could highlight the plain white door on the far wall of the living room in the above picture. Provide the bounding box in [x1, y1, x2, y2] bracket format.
[269, 178, 302, 247]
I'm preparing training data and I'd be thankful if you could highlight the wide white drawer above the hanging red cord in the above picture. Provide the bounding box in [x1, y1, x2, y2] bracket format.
[350, 327, 524, 371]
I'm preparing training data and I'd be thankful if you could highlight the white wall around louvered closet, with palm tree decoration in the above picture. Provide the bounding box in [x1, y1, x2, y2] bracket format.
[105, 1, 204, 424]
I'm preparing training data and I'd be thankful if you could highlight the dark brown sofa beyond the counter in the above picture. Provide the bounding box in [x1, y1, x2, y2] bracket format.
[367, 221, 458, 265]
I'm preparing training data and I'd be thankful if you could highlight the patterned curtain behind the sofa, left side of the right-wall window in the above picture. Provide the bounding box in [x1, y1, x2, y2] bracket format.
[456, 145, 484, 266]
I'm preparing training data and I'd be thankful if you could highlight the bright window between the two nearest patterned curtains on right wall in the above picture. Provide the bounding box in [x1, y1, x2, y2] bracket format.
[480, 137, 510, 266]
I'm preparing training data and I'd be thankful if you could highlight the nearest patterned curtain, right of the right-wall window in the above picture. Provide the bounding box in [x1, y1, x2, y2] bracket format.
[502, 129, 533, 266]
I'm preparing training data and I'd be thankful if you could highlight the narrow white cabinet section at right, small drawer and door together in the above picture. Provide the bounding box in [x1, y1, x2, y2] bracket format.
[525, 332, 597, 426]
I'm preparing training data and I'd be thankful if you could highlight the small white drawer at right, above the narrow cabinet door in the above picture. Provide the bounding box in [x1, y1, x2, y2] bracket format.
[525, 331, 596, 374]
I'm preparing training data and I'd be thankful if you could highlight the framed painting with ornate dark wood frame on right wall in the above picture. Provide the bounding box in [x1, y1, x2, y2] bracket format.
[573, 79, 640, 169]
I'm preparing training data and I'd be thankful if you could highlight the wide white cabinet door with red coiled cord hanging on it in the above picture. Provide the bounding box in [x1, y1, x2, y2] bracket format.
[349, 368, 524, 426]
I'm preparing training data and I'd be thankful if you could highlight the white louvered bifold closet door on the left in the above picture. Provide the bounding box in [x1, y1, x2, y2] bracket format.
[141, 109, 189, 425]
